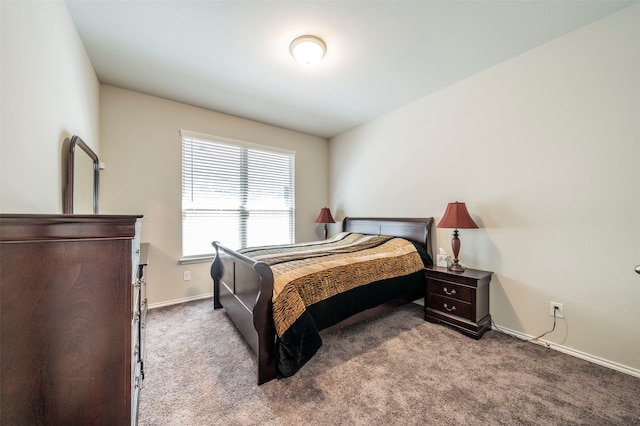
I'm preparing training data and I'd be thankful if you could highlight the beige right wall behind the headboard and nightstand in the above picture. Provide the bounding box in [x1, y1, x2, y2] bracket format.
[329, 6, 640, 376]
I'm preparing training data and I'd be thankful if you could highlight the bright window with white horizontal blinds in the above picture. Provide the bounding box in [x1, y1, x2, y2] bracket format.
[182, 130, 295, 259]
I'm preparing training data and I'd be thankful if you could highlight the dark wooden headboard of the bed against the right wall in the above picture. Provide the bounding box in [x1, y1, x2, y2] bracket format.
[342, 217, 434, 259]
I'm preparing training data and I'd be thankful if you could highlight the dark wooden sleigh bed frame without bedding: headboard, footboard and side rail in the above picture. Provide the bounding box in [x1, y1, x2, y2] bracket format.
[211, 218, 433, 385]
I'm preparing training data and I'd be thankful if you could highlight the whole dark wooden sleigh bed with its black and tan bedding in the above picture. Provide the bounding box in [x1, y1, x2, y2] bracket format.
[211, 218, 433, 385]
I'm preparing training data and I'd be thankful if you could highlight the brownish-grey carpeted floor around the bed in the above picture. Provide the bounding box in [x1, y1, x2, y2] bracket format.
[139, 299, 640, 426]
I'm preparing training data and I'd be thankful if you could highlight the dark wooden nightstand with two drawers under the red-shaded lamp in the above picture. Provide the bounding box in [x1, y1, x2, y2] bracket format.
[424, 266, 493, 339]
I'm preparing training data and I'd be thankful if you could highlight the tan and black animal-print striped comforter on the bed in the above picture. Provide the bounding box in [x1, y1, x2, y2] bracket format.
[240, 233, 424, 336]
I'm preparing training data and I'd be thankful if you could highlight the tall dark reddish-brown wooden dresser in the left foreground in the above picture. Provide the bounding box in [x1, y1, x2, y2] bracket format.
[0, 214, 146, 425]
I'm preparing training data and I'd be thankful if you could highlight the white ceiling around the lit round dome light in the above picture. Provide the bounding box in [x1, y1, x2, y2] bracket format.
[66, 0, 637, 138]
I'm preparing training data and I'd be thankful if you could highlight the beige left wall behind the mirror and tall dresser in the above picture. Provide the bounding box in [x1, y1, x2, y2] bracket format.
[0, 1, 100, 213]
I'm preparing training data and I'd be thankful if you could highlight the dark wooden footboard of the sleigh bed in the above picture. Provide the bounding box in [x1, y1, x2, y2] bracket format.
[211, 242, 276, 385]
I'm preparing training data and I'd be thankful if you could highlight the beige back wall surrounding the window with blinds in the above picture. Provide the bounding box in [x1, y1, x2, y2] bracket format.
[100, 85, 329, 306]
